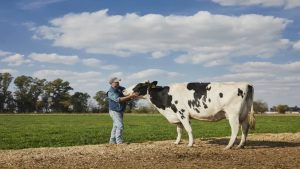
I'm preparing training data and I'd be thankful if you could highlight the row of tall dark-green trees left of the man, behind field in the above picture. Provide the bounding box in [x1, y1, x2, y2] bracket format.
[0, 73, 96, 113]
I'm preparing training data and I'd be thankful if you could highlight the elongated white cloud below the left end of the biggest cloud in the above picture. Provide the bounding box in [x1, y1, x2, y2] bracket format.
[29, 53, 80, 65]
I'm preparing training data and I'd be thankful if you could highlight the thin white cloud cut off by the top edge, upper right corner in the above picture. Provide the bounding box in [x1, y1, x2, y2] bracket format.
[212, 0, 300, 9]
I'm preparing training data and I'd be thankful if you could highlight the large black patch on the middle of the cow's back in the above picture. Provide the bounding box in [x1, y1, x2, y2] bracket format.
[187, 83, 211, 107]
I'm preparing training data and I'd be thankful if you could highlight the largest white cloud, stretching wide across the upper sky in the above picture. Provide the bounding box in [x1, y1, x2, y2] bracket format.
[34, 10, 291, 66]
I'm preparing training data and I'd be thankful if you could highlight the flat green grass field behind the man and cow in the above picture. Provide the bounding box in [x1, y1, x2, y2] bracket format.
[0, 114, 300, 149]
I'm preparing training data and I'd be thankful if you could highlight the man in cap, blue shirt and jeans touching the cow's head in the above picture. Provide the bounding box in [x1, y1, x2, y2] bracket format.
[107, 77, 138, 144]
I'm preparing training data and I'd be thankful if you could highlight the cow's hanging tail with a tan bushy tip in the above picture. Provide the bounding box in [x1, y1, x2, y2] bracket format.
[240, 85, 256, 130]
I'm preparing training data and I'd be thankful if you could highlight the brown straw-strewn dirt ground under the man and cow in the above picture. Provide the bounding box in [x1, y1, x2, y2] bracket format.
[0, 133, 300, 169]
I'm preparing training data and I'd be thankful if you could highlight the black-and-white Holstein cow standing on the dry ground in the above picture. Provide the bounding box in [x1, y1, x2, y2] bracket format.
[128, 81, 255, 149]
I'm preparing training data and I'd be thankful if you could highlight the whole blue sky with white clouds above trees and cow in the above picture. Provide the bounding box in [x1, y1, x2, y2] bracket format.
[0, 0, 300, 106]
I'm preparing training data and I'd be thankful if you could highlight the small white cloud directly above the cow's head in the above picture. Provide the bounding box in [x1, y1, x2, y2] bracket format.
[128, 69, 182, 79]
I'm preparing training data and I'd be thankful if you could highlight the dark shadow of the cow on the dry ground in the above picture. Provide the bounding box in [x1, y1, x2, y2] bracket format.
[206, 138, 300, 149]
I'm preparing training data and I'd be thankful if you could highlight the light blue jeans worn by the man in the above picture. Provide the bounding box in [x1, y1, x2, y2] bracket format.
[109, 110, 124, 144]
